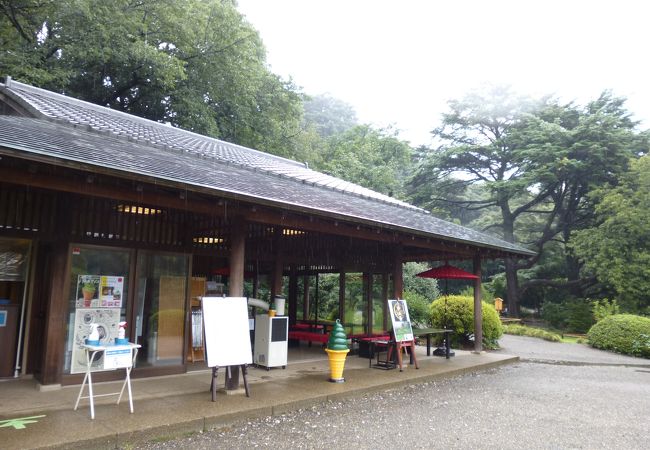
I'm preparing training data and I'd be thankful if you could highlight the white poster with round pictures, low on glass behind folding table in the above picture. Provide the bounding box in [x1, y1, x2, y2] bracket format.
[70, 308, 120, 373]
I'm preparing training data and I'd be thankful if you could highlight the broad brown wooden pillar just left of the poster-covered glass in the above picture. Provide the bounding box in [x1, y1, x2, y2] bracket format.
[40, 241, 68, 385]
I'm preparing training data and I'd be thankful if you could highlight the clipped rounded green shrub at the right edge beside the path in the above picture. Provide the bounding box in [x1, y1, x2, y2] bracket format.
[587, 314, 650, 358]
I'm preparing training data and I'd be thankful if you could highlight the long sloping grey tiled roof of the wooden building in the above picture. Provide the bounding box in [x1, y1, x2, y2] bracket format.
[0, 83, 532, 255]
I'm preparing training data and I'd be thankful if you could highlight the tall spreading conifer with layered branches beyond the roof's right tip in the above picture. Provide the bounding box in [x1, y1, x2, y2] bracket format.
[410, 88, 645, 312]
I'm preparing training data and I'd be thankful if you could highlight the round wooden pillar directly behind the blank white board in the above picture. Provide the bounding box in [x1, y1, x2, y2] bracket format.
[226, 219, 247, 390]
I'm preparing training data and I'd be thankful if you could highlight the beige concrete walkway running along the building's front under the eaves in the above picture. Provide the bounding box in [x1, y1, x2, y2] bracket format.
[0, 347, 517, 450]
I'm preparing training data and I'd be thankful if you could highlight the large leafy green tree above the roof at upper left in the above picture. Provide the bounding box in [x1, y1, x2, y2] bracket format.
[0, 0, 302, 156]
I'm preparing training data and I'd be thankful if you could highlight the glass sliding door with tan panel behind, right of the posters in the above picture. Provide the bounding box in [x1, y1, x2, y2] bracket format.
[135, 252, 189, 367]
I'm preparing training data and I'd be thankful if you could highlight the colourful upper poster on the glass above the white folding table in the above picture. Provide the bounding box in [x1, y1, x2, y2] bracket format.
[76, 275, 124, 308]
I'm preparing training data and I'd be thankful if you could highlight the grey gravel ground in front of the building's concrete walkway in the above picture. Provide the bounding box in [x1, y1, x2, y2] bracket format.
[134, 336, 650, 449]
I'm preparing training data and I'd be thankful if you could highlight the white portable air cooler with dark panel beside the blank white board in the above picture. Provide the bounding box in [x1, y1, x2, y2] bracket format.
[253, 314, 289, 370]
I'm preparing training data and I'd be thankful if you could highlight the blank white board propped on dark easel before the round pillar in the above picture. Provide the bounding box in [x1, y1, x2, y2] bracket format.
[201, 297, 253, 367]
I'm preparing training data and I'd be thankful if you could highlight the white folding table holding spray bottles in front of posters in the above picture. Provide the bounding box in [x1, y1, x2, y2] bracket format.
[74, 342, 141, 419]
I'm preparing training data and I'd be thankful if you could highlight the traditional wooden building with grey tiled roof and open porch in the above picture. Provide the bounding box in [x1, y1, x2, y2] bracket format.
[0, 77, 533, 384]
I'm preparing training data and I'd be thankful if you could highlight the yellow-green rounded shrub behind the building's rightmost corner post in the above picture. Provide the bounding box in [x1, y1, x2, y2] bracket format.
[431, 295, 503, 348]
